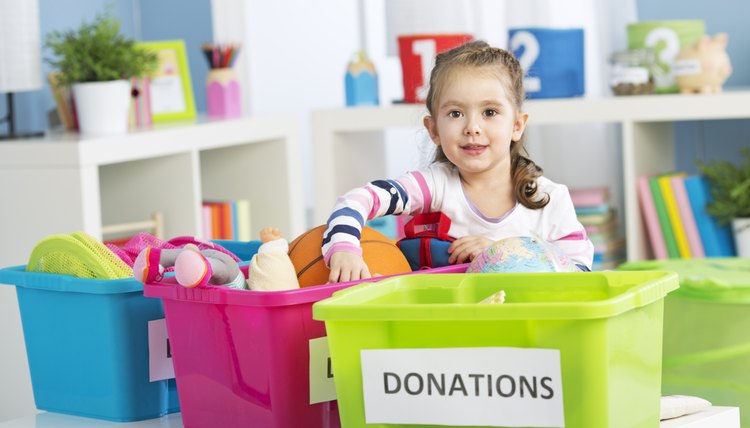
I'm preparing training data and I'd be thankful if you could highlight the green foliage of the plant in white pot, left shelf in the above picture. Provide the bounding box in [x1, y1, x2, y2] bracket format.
[45, 13, 157, 85]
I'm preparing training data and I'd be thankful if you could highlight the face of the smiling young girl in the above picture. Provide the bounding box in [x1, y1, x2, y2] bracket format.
[424, 69, 528, 179]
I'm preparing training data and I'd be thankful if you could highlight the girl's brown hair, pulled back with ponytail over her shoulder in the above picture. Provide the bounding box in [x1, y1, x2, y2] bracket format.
[426, 40, 549, 209]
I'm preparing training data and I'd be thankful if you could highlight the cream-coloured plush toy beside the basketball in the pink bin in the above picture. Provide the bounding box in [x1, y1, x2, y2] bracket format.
[247, 227, 299, 291]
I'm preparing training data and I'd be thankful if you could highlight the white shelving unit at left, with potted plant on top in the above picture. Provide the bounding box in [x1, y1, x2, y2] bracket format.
[0, 117, 305, 266]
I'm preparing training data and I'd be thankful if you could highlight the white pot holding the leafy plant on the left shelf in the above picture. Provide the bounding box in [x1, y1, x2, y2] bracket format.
[73, 80, 131, 135]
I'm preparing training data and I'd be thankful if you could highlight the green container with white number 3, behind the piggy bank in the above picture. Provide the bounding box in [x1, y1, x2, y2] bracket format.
[627, 19, 706, 93]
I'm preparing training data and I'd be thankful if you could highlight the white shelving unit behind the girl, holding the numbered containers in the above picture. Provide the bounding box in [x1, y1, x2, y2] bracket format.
[312, 91, 750, 260]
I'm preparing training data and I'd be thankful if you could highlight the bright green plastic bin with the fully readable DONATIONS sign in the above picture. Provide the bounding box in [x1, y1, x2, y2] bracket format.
[313, 272, 678, 428]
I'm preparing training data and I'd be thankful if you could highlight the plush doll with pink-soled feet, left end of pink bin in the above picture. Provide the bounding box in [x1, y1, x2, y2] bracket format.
[133, 244, 246, 290]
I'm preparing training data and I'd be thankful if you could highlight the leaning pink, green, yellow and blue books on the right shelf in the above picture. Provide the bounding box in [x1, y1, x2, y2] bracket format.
[638, 172, 735, 259]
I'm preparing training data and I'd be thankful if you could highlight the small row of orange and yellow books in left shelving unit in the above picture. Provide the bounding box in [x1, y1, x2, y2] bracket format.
[203, 199, 253, 241]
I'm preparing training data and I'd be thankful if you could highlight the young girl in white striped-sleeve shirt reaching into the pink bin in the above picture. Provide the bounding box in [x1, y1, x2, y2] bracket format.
[322, 41, 594, 282]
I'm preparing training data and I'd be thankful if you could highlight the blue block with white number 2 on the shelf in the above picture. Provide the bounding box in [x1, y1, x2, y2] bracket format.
[508, 28, 584, 98]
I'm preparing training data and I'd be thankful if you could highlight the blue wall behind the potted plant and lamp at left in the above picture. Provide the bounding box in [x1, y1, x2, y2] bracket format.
[0, 0, 213, 134]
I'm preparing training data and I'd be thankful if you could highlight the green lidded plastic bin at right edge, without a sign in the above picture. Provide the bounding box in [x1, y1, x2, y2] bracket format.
[619, 258, 750, 428]
